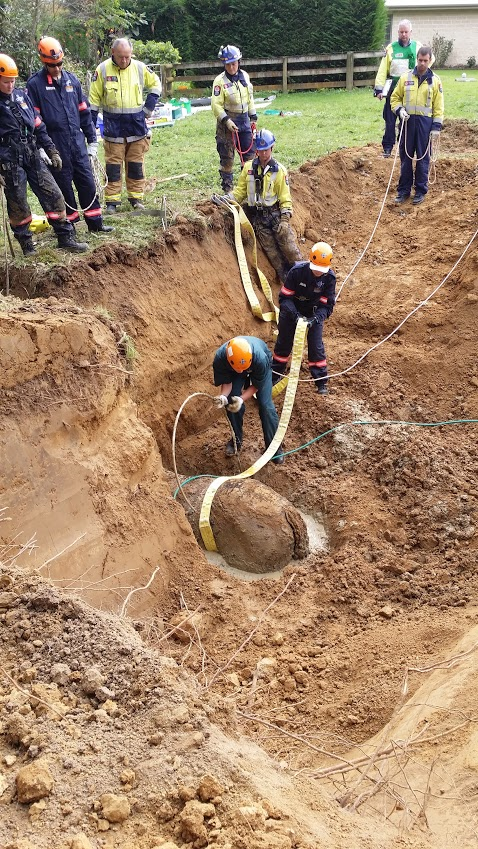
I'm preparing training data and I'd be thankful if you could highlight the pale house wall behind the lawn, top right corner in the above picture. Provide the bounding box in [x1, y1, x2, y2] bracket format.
[390, 9, 478, 67]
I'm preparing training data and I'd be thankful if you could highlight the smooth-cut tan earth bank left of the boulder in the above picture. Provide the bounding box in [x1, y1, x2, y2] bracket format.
[0, 300, 207, 616]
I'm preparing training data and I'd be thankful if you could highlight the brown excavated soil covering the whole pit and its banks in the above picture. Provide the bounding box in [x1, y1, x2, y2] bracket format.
[0, 122, 478, 849]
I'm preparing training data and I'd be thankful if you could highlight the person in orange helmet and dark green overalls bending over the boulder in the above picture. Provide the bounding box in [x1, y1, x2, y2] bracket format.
[213, 336, 284, 465]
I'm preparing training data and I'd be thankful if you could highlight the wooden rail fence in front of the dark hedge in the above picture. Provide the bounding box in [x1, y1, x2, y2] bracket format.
[155, 51, 383, 97]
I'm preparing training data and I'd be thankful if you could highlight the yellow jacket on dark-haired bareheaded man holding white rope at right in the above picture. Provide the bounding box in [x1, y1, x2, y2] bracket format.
[390, 68, 445, 130]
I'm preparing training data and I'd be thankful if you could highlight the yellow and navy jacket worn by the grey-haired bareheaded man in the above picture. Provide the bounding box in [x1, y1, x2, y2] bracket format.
[90, 58, 161, 142]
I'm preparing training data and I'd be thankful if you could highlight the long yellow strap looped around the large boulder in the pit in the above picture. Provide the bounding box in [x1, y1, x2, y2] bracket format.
[199, 318, 307, 551]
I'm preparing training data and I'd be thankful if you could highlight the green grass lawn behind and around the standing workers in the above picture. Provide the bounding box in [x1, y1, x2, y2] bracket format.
[0, 69, 478, 263]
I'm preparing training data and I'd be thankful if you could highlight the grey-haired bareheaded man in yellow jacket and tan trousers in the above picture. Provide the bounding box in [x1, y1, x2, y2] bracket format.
[90, 38, 161, 215]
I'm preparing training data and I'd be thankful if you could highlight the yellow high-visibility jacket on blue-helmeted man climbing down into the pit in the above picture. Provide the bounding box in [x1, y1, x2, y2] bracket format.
[232, 157, 292, 212]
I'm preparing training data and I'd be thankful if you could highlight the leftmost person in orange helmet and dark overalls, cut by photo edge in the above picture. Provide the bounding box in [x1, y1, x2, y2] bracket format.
[0, 53, 88, 256]
